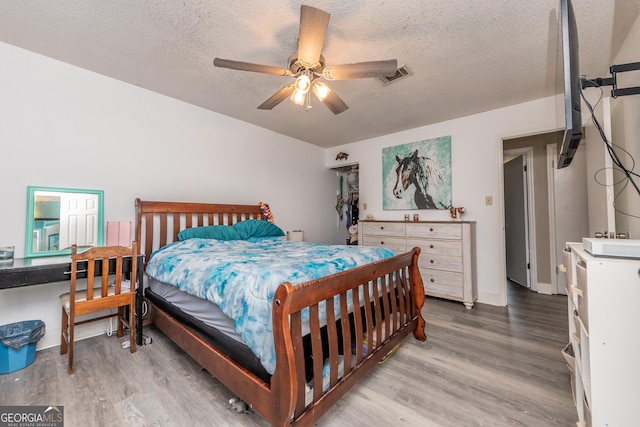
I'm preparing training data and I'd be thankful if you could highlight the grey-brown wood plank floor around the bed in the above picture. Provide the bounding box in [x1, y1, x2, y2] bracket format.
[0, 287, 576, 427]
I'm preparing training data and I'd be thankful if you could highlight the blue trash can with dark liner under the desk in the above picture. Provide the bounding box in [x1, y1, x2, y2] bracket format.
[0, 320, 45, 374]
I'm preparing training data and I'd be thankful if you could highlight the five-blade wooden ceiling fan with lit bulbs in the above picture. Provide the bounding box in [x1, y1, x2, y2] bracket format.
[213, 5, 398, 114]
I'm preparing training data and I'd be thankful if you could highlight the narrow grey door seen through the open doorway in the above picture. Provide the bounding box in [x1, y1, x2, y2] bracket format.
[503, 155, 531, 288]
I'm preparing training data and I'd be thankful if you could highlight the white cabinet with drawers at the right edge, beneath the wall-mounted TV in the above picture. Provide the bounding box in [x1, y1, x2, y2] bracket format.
[564, 243, 640, 426]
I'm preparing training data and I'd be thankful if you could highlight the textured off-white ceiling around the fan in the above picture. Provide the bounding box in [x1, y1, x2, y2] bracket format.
[0, 0, 640, 147]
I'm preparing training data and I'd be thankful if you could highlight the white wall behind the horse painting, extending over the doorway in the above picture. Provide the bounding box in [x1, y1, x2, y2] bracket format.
[326, 97, 562, 305]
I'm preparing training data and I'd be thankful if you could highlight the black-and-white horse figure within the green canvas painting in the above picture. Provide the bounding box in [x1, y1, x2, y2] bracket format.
[393, 150, 444, 209]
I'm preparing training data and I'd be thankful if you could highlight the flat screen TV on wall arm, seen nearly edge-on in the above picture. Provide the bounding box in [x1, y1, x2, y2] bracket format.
[558, 0, 582, 169]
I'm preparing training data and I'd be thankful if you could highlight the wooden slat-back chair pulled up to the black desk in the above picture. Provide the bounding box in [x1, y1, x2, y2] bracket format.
[60, 241, 138, 375]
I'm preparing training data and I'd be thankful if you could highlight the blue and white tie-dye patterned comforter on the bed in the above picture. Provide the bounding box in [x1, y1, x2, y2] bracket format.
[146, 238, 395, 374]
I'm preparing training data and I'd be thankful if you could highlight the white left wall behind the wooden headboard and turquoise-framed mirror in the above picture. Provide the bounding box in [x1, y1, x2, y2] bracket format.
[0, 43, 344, 348]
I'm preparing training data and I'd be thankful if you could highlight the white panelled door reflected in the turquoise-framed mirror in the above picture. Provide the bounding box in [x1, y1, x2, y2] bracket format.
[60, 193, 98, 249]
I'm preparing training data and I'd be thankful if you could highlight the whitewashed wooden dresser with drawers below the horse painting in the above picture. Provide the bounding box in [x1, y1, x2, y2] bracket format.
[358, 221, 478, 308]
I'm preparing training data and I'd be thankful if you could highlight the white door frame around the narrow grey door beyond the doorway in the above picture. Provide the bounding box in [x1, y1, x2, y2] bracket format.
[502, 147, 538, 292]
